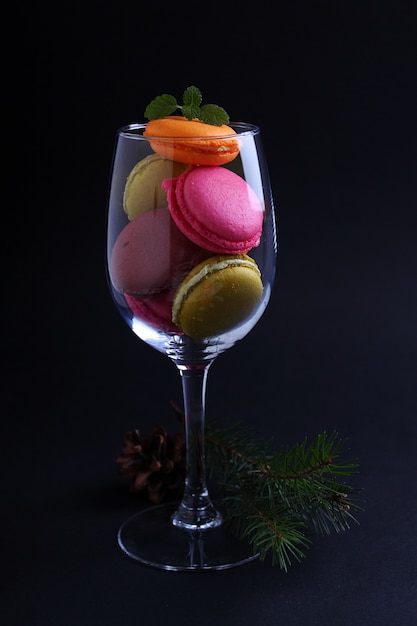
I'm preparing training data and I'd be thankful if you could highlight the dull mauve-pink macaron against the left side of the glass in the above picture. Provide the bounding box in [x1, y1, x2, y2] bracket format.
[110, 207, 207, 296]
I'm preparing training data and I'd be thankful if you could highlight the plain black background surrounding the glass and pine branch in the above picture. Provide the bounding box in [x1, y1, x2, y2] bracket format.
[1, 0, 417, 626]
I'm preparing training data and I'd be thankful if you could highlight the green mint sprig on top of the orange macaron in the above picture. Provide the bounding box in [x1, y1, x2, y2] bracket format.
[144, 85, 230, 126]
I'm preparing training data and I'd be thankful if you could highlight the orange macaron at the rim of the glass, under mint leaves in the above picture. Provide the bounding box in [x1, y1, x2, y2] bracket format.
[143, 115, 240, 165]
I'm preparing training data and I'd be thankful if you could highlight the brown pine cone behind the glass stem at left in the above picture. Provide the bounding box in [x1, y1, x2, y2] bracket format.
[116, 424, 185, 504]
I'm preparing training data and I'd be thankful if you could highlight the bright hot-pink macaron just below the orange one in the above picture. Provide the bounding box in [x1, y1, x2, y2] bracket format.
[162, 166, 264, 254]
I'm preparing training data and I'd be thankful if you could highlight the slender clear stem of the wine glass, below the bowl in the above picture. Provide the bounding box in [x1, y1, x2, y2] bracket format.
[171, 363, 222, 531]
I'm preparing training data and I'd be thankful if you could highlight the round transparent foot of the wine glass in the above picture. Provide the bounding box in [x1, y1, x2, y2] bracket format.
[117, 503, 259, 572]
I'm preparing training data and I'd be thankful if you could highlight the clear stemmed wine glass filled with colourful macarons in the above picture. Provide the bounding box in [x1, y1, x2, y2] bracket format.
[107, 122, 277, 571]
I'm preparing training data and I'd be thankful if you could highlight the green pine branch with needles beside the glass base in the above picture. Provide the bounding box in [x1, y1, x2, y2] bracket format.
[206, 424, 361, 571]
